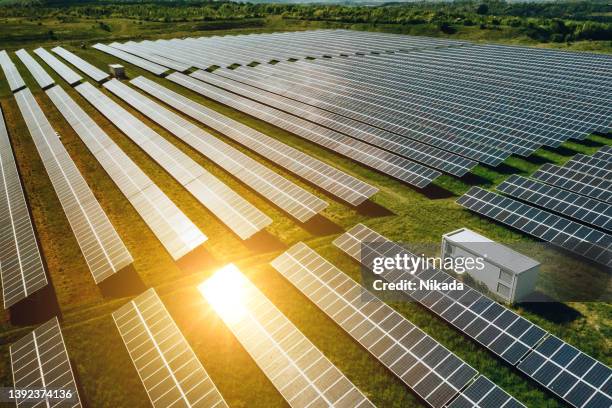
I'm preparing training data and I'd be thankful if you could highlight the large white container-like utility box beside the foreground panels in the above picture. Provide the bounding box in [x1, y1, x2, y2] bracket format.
[441, 228, 540, 303]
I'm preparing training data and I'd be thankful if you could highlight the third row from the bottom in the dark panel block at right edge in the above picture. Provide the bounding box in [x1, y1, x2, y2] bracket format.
[531, 163, 612, 203]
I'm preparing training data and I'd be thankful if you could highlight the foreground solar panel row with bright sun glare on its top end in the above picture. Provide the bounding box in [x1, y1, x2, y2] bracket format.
[198, 264, 374, 408]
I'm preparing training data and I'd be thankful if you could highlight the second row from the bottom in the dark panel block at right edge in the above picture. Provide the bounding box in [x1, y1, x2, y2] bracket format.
[497, 175, 612, 231]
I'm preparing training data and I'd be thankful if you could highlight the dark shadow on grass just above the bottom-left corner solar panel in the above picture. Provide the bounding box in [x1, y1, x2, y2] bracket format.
[10, 283, 62, 326]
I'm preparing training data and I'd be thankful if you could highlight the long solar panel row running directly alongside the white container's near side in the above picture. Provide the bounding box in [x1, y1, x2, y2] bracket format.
[334, 223, 612, 408]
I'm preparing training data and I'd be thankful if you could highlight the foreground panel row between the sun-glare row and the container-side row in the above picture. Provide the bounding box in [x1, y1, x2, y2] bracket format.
[271, 243, 523, 407]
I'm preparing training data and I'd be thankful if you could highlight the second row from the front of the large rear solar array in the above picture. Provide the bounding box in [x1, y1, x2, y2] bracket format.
[198, 69, 477, 177]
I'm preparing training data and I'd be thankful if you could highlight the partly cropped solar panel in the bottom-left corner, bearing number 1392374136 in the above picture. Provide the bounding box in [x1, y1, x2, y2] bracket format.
[10, 317, 81, 408]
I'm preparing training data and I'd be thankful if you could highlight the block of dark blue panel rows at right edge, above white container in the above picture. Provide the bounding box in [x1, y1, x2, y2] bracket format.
[457, 147, 612, 267]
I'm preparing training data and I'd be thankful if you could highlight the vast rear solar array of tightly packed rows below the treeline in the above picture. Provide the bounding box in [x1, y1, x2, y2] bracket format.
[92, 30, 612, 175]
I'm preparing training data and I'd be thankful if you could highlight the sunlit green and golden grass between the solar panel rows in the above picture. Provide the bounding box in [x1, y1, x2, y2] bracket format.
[0, 22, 612, 408]
